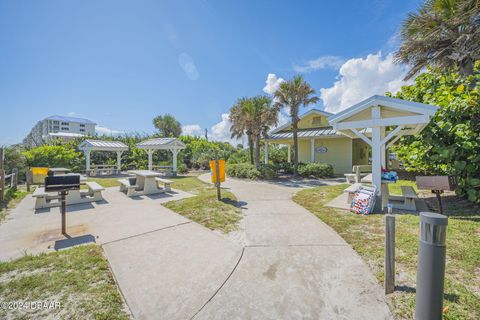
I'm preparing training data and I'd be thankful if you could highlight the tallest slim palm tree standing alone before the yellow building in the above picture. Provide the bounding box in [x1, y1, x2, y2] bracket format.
[273, 75, 319, 176]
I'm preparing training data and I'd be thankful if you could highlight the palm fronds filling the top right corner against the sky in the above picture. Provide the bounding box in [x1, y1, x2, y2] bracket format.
[396, 0, 480, 80]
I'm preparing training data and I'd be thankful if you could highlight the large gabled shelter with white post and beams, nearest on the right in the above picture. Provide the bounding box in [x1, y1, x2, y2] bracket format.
[328, 95, 438, 209]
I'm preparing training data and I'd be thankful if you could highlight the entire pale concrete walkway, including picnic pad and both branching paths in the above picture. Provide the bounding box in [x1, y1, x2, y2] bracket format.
[0, 175, 391, 319]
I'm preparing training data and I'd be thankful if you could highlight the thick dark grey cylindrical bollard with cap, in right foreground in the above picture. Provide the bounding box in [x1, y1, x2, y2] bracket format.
[415, 212, 448, 320]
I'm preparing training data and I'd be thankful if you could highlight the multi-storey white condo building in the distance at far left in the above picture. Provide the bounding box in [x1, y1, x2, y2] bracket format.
[23, 116, 96, 148]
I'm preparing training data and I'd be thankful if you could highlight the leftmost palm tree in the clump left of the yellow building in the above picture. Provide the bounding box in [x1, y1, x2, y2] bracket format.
[229, 97, 255, 164]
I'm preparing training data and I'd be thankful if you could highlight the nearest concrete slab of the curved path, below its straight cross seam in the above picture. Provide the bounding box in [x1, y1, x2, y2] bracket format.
[194, 246, 392, 320]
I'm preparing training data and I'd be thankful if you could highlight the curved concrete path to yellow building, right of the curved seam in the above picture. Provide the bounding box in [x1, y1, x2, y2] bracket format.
[194, 175, 392, 319]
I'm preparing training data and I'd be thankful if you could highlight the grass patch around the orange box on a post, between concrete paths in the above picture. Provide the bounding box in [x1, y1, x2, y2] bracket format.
[164, 176, 242, 233]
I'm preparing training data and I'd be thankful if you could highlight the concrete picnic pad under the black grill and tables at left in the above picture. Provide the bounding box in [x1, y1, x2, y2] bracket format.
[0, 187, 193, 261]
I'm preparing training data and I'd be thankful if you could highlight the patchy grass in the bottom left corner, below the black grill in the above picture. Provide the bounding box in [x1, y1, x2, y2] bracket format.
[0, 245, 129, 319]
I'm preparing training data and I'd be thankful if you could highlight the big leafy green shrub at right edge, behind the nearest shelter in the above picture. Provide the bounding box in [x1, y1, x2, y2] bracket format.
[394, 62, 480, 203]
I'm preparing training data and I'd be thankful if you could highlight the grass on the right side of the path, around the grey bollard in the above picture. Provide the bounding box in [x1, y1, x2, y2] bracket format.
[294, 181, 480, 319]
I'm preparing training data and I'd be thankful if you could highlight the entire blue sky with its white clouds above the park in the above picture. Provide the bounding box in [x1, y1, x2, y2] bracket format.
[0, 0, 419, 145]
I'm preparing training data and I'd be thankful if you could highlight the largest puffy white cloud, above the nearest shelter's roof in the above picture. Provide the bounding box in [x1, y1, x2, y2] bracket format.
[320, 52, 408, 113]
